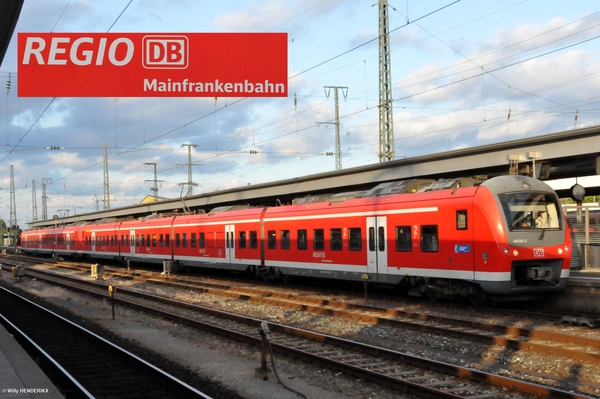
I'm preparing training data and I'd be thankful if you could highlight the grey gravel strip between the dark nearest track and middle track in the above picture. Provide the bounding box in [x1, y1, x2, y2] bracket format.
[0, 273, 420, 399]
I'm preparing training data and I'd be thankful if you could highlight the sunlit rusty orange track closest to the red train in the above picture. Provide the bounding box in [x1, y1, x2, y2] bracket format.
[31, 260, 600, 365]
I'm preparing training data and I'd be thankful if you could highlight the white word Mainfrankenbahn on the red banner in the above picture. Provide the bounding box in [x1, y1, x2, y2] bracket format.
[144, 79, 285, 94]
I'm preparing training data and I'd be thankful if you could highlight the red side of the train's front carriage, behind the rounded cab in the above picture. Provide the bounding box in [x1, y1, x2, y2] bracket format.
[264, 188, 476, 284]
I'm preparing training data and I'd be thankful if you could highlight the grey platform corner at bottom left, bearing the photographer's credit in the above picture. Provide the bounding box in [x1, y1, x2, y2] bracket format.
[0, 325, 64, 399]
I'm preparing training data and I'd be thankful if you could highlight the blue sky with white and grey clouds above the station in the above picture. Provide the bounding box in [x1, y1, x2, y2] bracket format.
[0, 0, 600, 228]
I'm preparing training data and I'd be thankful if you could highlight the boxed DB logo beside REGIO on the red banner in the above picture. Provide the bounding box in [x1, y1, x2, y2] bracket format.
[142, 35, 189, 69]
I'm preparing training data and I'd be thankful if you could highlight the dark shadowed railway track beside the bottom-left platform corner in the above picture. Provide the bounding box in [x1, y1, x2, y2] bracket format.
[0, 287, 210, 399]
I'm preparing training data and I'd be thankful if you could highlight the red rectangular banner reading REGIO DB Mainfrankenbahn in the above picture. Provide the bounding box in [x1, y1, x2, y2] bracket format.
[18, 33, 288, 97]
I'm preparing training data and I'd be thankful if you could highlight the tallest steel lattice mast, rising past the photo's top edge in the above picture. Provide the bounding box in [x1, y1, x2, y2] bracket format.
[379, 0, 395, 162]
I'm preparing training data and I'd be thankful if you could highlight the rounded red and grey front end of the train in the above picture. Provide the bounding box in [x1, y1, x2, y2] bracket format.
[474, 176, 571, 299]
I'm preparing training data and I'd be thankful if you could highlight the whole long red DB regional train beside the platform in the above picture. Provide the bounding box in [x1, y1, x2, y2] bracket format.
[21, 176, 571, 300]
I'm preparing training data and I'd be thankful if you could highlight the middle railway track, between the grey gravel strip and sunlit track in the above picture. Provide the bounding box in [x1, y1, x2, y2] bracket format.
[3, 260, 588, 398]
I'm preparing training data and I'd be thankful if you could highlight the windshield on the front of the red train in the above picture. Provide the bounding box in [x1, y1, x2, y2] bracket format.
[498, 192, 562, 231]
